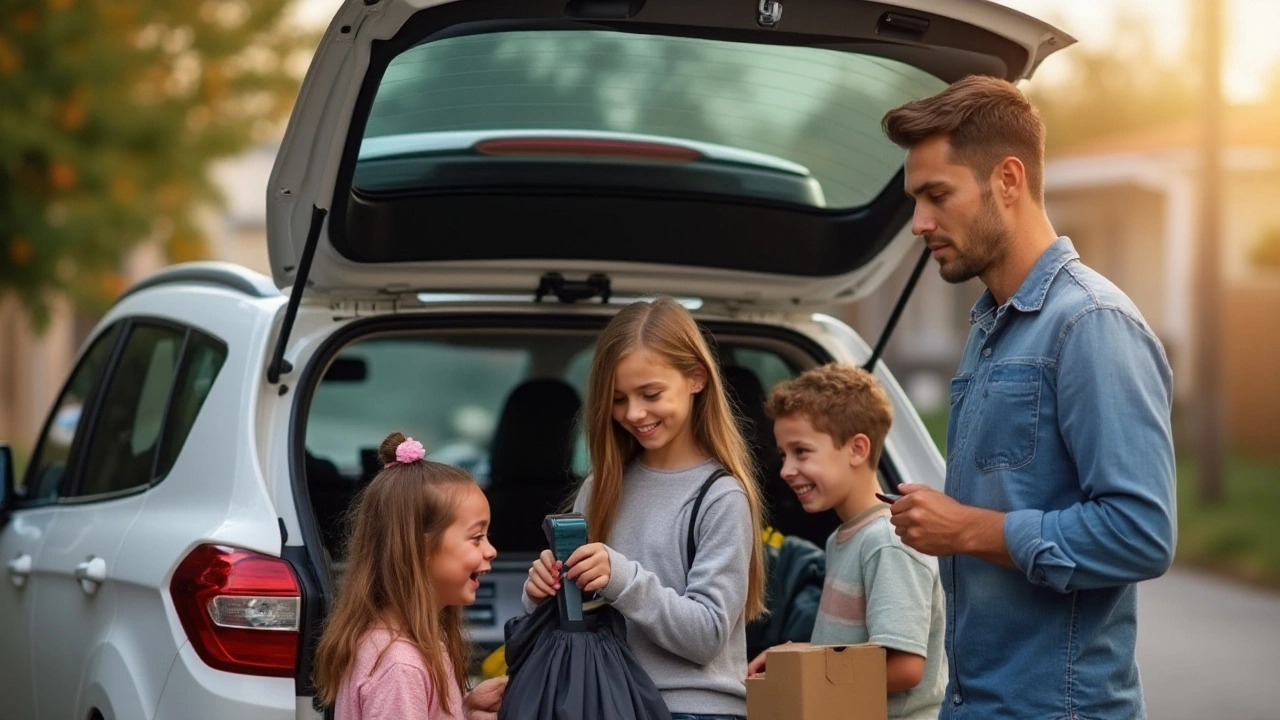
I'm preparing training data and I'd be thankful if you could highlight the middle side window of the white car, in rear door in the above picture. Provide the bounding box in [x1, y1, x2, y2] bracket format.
[73, 324, 186, 497]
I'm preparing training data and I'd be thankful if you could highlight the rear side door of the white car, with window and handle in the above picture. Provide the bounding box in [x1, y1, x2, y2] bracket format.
[31, 320, 184, 717]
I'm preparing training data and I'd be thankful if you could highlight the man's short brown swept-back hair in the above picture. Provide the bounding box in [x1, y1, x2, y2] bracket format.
[881, 76, 1044, 205]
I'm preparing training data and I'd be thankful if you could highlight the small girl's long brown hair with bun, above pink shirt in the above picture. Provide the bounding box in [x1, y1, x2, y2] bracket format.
[314, 433, 475, 714]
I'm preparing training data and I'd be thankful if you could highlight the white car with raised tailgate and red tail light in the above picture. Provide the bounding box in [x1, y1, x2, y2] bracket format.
[0, 0, 1071, 720]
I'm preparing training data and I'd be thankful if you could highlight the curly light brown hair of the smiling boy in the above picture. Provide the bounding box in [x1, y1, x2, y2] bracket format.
[764, 363, 893, 466]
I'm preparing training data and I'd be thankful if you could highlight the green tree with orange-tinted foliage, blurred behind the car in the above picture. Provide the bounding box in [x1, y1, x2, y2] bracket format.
[0, 0, 315, 327]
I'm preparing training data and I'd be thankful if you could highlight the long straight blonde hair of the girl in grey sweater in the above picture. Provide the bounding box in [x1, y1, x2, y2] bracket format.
[582, 297, 764, 620]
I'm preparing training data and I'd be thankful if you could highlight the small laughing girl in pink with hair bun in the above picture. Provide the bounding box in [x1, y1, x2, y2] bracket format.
[315, 433, 506, 720]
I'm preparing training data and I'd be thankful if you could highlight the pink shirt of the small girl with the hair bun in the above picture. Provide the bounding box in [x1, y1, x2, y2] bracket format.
[334, 628, 462, 720]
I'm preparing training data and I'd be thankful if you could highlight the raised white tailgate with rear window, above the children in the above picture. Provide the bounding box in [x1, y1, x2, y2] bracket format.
[268, 0, 1073, 307]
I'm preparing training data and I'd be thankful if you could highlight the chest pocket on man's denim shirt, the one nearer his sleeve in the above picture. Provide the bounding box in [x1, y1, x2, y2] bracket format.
[973, 359, 1043, 473]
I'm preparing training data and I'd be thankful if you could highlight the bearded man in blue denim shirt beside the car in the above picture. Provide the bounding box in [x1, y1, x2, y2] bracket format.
[883, 77, 1175, 720]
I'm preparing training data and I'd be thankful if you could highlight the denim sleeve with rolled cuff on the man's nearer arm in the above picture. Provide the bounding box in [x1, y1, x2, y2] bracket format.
[1004, 309, 1176, 592]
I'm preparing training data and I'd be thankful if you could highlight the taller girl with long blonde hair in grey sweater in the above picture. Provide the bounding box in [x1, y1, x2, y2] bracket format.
[525, 297, 764, 720]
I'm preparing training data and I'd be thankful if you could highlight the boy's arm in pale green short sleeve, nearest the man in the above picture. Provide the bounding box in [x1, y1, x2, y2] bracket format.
[863, 543, 937, 693]
